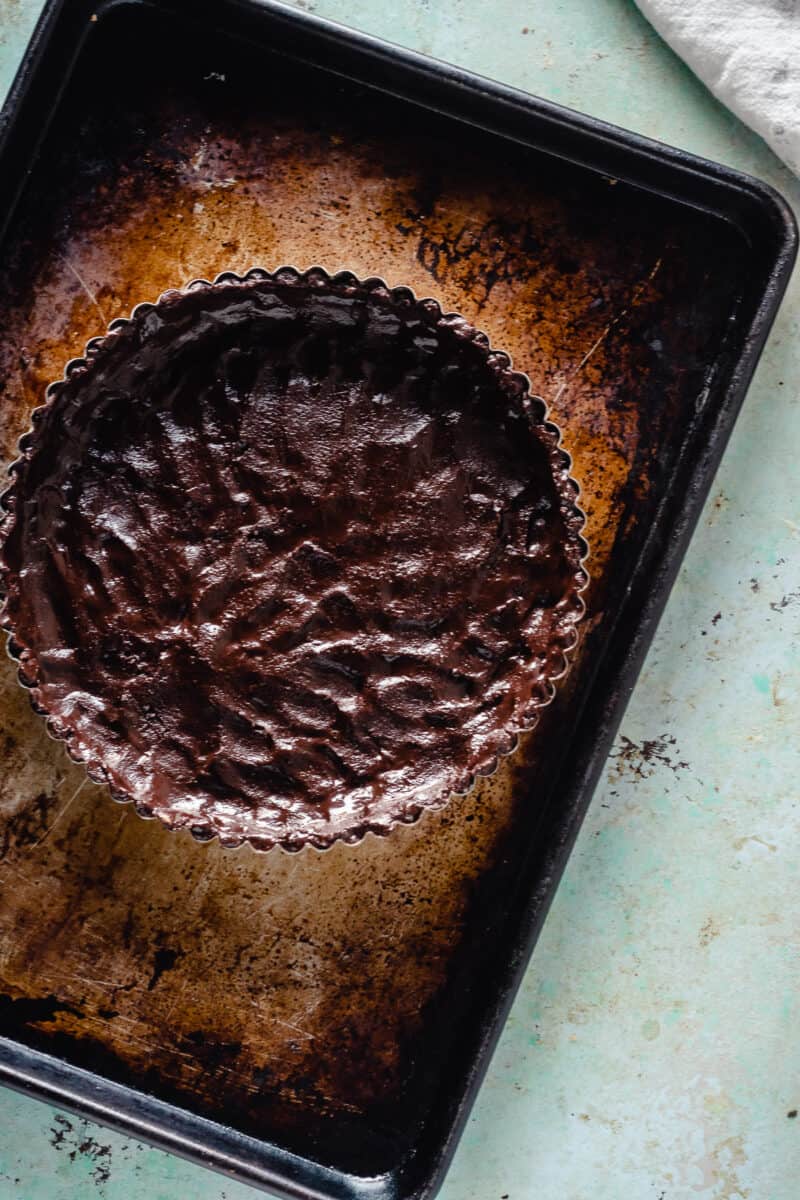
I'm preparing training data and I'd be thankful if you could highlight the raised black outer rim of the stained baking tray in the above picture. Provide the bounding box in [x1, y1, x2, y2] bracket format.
[0, 0, 798, 1200]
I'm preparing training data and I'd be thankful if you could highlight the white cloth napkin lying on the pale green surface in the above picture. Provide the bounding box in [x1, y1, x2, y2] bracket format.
[637, 0, 800, 175]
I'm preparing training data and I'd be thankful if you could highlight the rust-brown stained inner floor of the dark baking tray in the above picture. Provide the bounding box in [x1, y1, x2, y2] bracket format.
[0, 7, 739, 1170]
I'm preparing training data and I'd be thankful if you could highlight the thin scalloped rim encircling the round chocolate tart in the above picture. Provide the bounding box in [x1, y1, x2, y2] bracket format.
[0, 266, 590, 854]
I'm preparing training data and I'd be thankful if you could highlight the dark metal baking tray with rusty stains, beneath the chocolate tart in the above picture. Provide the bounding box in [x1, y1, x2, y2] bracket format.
[0, 0, 795, 1200]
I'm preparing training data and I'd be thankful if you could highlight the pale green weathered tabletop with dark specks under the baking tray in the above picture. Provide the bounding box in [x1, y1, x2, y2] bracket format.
[0, 0, 800, 1200]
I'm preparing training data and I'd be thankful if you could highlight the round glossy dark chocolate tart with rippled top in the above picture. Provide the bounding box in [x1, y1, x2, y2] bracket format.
[2, 272, 585, 848]
